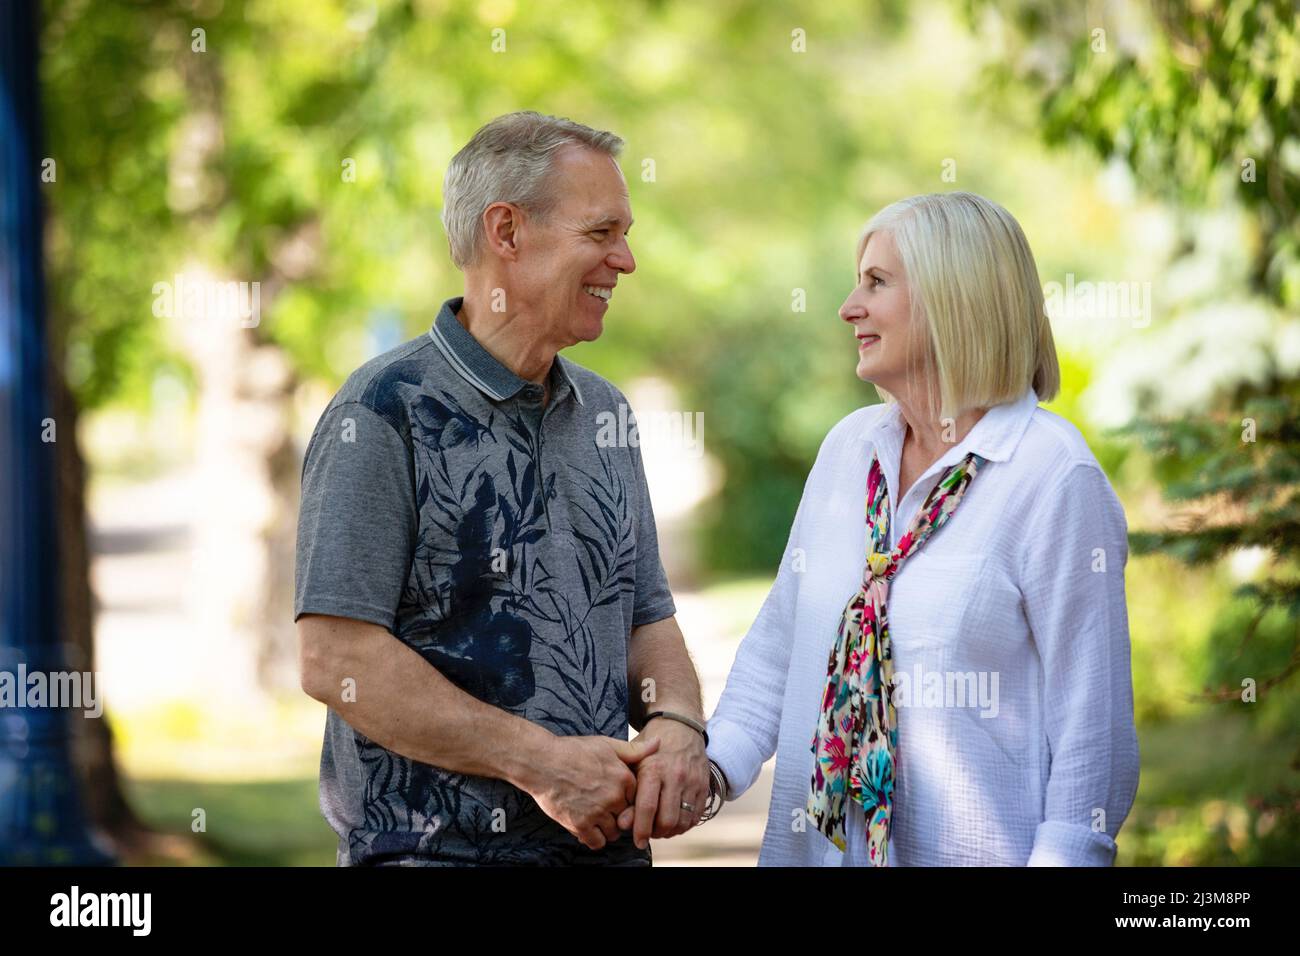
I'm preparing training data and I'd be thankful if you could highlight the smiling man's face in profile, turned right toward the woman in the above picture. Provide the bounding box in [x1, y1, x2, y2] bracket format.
[514, 146, 637, 349]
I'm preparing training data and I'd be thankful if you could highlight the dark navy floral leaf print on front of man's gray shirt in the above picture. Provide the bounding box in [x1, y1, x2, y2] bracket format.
[356, 392, 637, 862]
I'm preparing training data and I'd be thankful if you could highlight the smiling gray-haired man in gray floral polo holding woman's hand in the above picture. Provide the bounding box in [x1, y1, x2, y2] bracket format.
[295, 112, 709, 865]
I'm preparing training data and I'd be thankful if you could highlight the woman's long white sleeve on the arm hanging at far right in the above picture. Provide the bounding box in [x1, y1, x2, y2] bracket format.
[1021, 460, 1139, 866]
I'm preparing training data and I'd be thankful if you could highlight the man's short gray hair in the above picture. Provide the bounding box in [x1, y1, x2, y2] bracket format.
[442, 109, 623, 269]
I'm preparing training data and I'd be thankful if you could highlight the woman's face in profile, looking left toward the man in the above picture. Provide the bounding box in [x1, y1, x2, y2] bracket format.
[840, 233, 924, 395]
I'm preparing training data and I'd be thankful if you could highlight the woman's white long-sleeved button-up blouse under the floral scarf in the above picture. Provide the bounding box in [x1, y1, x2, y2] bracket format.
[709, 389, 1138, 866]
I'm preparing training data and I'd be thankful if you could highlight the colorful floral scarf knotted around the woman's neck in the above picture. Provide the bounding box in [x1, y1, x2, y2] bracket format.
[807, 453, 984, 866]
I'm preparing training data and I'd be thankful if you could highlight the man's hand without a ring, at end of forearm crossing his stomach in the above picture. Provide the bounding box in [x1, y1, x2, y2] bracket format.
[524, 735, 655, 849]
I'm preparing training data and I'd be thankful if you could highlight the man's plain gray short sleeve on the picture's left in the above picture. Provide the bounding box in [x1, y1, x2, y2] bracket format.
[294, 402, 417, 631]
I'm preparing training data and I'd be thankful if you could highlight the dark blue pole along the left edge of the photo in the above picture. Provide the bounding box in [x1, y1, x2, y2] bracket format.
[0, 0, 112, 866]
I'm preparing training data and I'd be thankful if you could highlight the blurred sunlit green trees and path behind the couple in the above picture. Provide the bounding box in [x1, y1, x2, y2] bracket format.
[30, 0, 1300, 865]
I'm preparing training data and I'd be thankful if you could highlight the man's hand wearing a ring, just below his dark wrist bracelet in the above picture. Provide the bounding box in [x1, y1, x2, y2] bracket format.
[618, 717, 709, 849]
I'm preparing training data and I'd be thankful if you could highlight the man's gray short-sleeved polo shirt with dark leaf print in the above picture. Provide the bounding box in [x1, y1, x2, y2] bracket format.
[294, 298, 676, 865]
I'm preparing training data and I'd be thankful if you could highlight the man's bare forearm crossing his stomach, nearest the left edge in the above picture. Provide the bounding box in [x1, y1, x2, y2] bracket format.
[298, 615, 553, 790]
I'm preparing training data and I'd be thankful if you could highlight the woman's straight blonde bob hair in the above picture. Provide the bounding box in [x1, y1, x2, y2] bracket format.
[854, 193, 1061, 420]
